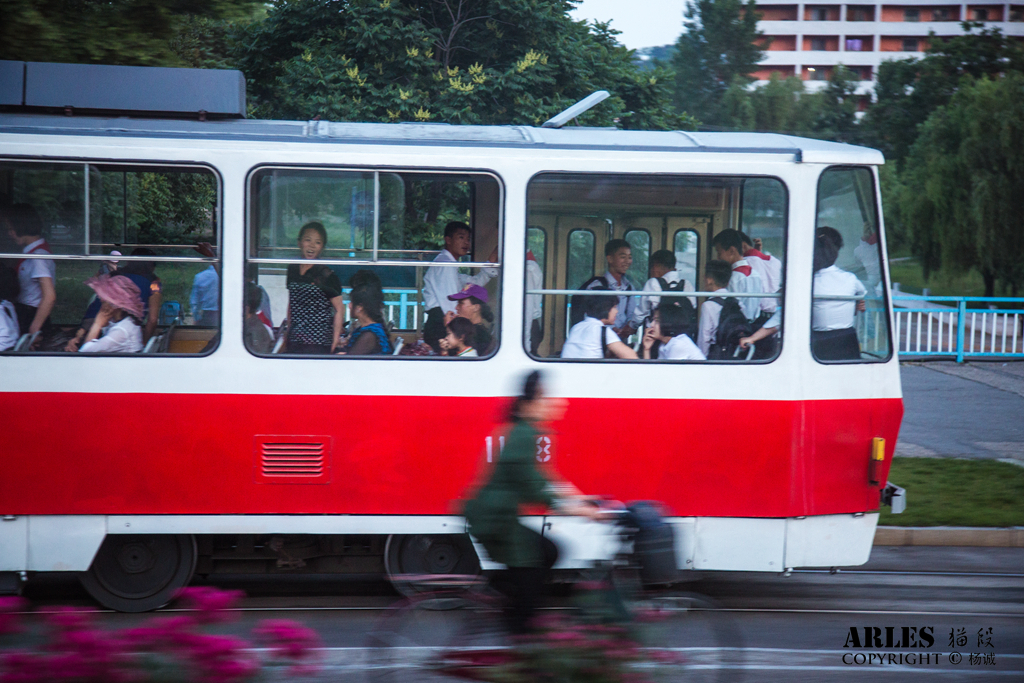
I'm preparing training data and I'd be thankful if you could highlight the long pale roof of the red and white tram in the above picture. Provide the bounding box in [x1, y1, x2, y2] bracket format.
[0, 114, 885, 164]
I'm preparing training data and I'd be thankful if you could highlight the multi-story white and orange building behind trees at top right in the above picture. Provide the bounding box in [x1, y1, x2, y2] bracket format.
[754, 0, 1024, 100]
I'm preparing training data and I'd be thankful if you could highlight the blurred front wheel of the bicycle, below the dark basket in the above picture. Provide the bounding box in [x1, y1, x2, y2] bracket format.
[631, 593, 745, 683]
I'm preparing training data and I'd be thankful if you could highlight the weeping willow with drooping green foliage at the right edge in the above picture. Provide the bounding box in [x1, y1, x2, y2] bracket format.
[899, 73, 1024, 296]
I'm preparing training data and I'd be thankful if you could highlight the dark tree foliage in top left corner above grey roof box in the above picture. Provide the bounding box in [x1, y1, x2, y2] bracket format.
[0, 0, 259, 67]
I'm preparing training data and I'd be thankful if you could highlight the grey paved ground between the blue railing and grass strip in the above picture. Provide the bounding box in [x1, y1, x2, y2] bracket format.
[896, 361, 1024, 464]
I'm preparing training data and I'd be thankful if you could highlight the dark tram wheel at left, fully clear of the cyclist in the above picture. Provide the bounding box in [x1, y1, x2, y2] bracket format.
[81, 535, 198, 612]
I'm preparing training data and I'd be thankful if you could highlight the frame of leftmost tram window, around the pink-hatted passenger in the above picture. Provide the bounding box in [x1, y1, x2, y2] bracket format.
[0, 157, 224, 358]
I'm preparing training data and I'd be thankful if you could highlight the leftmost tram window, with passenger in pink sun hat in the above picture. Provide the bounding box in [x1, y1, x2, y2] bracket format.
[0, 161, 220, 355]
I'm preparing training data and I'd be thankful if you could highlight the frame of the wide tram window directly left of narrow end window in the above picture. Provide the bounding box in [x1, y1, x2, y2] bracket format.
[523, 171, 791, 367]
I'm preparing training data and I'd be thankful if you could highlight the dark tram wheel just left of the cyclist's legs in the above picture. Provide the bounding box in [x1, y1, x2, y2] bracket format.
[384, 533, 480, 597]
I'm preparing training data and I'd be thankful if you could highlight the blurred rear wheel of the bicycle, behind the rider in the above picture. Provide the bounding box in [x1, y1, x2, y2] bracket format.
[366, 593, 515, 683]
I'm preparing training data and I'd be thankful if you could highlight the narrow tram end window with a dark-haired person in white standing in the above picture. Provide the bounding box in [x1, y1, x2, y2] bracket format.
[811, 168, 891, 362]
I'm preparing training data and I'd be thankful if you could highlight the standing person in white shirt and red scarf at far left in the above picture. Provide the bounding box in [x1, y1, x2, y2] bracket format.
[0, 204, 57, 334]
